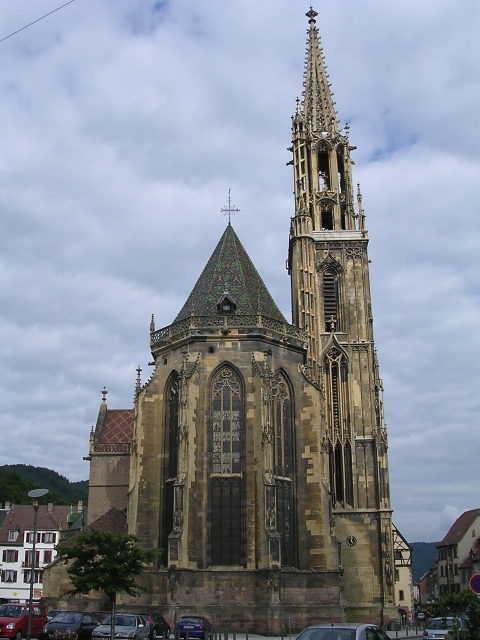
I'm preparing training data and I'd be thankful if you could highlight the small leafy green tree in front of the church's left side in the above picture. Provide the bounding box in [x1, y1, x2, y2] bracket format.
[57, 529, 160, 638]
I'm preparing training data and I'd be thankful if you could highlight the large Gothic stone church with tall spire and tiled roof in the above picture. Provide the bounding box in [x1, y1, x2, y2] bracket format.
[88, 9, 397, 633]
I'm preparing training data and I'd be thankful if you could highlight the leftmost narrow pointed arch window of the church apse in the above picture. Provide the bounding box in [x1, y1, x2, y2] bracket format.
[161, 373, 180, 566]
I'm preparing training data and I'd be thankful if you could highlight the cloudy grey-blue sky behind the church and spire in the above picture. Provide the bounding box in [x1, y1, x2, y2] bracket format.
[0, 0, 480, 542]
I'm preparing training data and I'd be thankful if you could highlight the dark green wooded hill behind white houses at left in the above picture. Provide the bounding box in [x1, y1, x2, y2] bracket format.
[0, 464, 88, 504]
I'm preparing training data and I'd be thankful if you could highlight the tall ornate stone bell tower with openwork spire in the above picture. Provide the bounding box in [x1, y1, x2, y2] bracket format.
[288, 8, 394, 619]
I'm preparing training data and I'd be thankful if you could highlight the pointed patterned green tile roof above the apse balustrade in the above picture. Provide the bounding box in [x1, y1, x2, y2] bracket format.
[174, 224, 286, 322]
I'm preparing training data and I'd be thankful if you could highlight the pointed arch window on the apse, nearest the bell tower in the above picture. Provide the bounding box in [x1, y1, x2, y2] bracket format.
[272, 373, 295, 567]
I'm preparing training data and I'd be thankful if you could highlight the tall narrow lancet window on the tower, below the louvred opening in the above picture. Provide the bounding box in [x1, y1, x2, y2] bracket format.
[324, 346, 353, 506]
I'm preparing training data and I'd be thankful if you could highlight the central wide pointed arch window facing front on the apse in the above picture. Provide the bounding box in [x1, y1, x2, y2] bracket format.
[209, 366, 245, 566]
